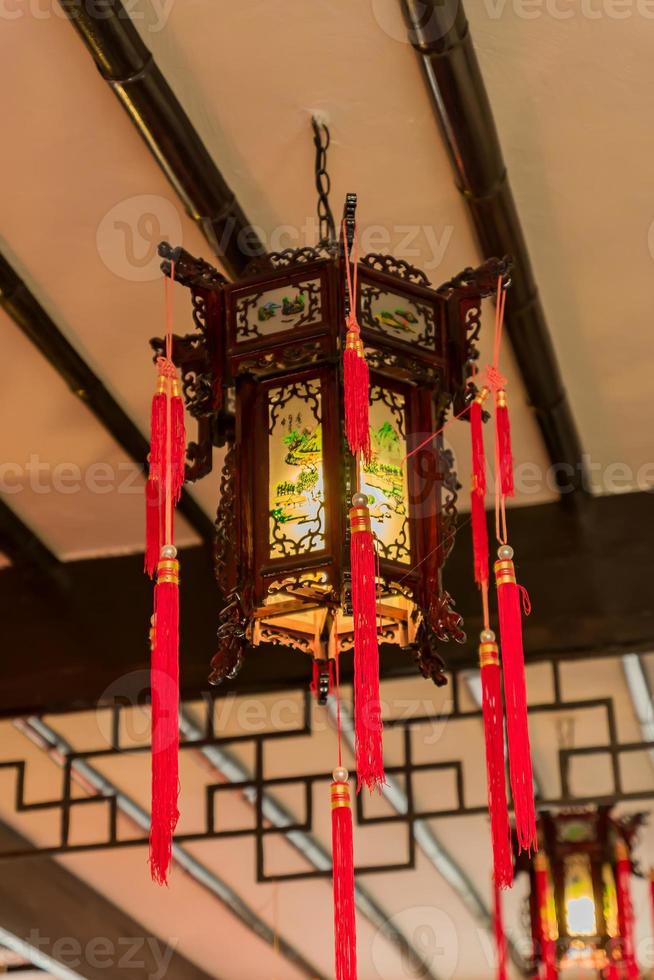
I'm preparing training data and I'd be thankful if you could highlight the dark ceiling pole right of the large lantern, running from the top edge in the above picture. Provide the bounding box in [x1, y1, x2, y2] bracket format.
[402, 0, 588, 492]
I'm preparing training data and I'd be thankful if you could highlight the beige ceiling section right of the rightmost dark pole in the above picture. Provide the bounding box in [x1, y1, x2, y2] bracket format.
[466, 2, 654, 492]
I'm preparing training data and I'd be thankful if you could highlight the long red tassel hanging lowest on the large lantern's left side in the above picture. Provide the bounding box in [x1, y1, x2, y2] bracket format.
[150, 545, 179, 885]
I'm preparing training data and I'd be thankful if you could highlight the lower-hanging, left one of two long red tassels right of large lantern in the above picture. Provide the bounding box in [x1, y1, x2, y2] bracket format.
[479, 630, 513, 888]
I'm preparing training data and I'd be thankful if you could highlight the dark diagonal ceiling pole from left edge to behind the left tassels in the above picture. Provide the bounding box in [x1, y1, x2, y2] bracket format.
[0, 253, 214, 541]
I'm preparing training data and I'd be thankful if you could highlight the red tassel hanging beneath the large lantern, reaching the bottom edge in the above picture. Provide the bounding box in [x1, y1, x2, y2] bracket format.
[331, 769, 357, 980]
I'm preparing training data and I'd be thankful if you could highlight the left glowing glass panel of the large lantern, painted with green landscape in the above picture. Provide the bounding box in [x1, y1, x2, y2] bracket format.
[268, 380, 325, 558]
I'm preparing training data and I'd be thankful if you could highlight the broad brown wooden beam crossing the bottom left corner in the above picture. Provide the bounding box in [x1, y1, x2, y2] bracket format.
[0, 823, 215, 980]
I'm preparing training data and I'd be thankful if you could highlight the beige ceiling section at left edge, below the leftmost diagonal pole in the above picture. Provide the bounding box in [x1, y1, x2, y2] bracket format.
[0, 311, 198, 559]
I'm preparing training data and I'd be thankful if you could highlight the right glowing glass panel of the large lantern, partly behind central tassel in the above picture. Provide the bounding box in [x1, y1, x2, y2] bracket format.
[361, 385, 411, 564]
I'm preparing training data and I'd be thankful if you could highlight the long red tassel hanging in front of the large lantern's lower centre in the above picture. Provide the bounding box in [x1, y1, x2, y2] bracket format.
[350, 502, 386, 792]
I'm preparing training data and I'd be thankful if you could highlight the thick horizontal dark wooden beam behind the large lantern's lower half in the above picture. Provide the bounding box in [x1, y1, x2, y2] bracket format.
[0, 493, 654, 716]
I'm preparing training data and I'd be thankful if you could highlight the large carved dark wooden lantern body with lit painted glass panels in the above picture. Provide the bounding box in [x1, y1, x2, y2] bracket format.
[153, 222, 510, 697]
